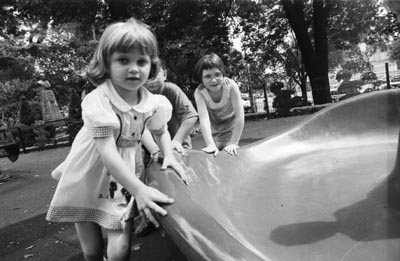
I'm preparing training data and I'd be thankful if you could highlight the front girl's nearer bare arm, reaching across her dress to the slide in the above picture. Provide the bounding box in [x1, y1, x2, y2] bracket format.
[94, 136, 174, 227]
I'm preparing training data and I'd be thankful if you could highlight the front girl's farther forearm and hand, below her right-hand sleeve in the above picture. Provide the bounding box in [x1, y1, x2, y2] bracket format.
[154, 131, 187, 185]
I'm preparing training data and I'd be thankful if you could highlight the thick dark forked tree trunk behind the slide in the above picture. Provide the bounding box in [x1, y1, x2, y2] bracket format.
[281, 0, 331, 104]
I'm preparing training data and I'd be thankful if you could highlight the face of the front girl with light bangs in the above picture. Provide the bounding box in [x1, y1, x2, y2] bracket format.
[109, 48, 151, 94]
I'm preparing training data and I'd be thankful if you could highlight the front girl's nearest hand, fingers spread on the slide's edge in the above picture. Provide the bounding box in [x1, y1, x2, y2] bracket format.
[135, 185, 174, 227]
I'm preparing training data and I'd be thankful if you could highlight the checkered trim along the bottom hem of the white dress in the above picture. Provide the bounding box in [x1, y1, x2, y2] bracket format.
[46, 206, 134, 229]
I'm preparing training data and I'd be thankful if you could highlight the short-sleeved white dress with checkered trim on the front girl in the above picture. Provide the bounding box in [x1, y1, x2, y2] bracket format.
[46, 78, 172, 229]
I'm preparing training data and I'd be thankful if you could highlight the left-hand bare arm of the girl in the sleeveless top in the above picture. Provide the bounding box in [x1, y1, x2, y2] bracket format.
[194, 90, 218, 156]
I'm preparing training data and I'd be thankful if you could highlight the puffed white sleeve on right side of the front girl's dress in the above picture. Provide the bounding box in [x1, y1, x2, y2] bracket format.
[147, 94, 172, 135]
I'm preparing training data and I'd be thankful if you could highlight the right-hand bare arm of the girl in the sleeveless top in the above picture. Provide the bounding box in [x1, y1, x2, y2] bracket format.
[224, 81, 244, 155]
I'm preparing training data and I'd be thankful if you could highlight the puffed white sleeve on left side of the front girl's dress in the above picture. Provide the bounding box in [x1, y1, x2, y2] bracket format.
[82, 89, 120, 138]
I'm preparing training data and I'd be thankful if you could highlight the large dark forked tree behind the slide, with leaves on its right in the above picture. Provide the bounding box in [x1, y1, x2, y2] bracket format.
[281, 0, 381, 104]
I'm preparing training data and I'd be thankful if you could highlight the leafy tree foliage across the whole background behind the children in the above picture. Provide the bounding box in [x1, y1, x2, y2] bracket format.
[0, 0, 399, 115]
